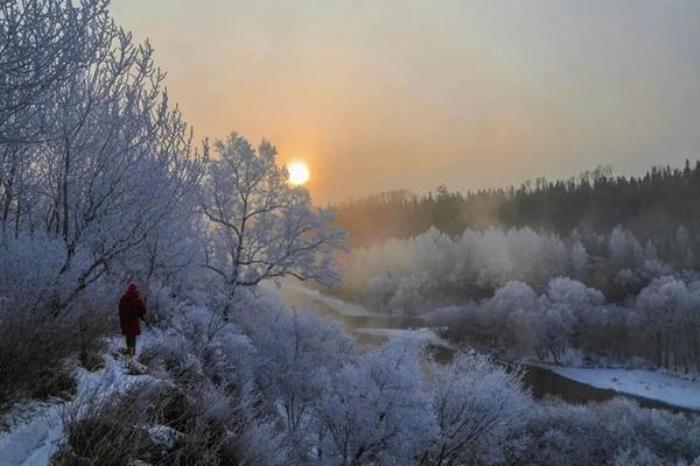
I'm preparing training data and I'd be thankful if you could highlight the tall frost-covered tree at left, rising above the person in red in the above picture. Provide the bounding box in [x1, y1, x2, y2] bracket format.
[0, 0, 203, 315]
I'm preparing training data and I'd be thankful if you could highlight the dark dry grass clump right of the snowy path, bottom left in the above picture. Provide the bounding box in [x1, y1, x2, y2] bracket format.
[52, 385, 231, 466]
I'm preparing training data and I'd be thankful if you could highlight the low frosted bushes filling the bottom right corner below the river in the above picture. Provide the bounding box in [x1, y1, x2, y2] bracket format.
[504, 399, 700, 466]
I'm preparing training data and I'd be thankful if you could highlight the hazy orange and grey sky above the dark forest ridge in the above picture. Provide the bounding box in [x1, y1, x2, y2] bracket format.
[112, 0, 700, 202]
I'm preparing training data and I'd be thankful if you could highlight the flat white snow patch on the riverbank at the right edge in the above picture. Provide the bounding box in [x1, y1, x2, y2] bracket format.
[546, 366, 700, 410]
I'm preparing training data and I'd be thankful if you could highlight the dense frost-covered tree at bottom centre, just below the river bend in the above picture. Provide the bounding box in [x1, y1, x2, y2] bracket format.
[317, 338, 435, 465]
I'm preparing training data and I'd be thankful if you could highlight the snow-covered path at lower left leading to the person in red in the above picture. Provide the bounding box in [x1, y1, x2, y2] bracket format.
[0, 334, 159, 466]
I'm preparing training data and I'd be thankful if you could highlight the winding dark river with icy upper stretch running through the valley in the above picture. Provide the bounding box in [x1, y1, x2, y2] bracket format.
[278, 285, 694, 412]
